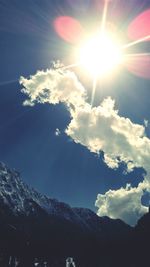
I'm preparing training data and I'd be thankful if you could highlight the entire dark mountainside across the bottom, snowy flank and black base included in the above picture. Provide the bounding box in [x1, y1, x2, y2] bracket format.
[0, 163, 150, 267]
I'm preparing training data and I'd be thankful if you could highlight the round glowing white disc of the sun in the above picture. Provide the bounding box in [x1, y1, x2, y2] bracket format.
[78, 32, 123, 78]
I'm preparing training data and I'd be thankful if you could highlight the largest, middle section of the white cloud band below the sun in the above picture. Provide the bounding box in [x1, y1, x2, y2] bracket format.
[66, 98, 150, 176]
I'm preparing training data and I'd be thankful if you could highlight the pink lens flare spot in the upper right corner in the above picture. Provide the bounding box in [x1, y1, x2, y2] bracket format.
[128, 9, 150, 41]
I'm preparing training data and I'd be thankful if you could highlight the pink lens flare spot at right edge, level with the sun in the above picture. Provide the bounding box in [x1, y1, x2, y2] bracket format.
[125, 55, 150, 79]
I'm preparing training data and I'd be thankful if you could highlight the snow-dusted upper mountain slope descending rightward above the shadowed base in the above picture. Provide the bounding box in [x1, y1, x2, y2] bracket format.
[0, 163, 128, 232]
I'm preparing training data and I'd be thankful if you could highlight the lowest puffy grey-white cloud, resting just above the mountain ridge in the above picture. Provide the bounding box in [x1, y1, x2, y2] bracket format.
[95, 184, 148, 226]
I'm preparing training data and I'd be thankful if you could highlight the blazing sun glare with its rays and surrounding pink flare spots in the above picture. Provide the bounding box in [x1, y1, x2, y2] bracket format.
[53, 5, 150, 80]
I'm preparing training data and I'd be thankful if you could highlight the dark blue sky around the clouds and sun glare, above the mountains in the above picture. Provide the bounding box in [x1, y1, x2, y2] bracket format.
[0, 0, 150, 213]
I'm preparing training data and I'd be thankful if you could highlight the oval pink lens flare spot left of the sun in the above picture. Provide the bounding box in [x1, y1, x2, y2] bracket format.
[54, 16, 84, 44]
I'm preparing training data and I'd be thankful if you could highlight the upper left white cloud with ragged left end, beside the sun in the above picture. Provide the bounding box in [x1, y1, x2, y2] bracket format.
[20, 65, 85, 106]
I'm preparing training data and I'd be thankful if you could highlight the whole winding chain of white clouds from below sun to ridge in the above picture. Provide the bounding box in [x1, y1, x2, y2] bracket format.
[20, 65, 150, 225]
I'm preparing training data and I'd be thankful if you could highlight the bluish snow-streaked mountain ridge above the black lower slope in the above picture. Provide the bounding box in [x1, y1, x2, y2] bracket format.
[0, 162, 130, 232]
